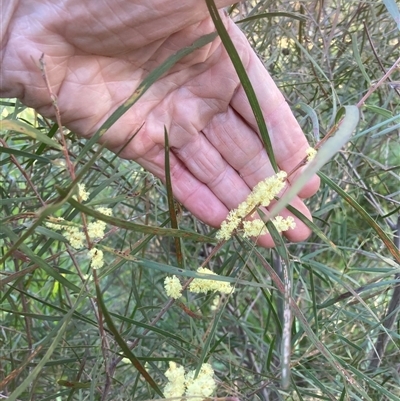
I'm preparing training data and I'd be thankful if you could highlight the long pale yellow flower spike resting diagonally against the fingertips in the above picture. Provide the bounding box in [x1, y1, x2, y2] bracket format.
[216, 171, 287, 240]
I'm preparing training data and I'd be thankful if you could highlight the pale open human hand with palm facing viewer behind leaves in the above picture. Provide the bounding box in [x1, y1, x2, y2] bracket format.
[0, 0, 319, 247]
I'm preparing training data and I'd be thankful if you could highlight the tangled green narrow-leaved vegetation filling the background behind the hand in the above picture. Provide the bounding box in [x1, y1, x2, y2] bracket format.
[0, 0, 400, 401]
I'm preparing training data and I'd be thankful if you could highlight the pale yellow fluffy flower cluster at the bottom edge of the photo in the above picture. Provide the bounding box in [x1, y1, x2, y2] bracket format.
[164, 362, 216, 401]
